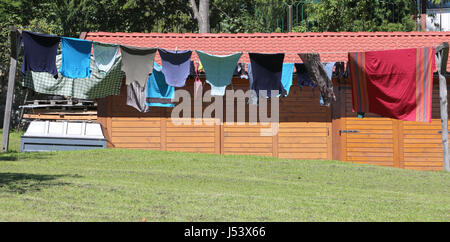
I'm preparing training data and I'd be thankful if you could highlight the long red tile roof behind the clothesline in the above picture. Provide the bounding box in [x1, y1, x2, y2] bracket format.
[86, 32, 450, 67]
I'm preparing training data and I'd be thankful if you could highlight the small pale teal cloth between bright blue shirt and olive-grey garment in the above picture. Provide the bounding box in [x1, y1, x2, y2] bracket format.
[93, 42, 119, 72]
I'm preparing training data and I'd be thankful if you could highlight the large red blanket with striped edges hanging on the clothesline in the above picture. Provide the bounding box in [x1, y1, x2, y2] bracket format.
[348, 47, 435, 122]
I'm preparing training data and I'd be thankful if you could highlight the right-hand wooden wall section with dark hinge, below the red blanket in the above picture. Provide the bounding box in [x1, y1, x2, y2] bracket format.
[333, 79, 443, 170]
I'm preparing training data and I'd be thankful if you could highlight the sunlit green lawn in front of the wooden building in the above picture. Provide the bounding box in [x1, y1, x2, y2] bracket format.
[0, 130, 450, 221]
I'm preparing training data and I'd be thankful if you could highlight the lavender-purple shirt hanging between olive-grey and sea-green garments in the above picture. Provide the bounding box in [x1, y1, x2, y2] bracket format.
[158, 49, 192, 87]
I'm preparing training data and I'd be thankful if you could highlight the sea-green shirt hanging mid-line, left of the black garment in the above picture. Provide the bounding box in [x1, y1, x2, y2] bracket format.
[197, 50, 242, 96]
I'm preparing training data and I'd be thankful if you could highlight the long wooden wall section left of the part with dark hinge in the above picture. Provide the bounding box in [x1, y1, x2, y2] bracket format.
[98, 79, 332, 159]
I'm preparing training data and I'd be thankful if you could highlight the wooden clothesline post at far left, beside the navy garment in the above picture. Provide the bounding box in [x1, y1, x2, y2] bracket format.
[2, 26, 19, 152]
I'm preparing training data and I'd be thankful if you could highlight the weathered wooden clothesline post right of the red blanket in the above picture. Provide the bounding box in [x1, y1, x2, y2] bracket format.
[435, 42, 450, 171]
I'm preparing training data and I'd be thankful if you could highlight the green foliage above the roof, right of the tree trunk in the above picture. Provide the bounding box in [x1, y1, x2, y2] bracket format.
[211, 0, 416, 33]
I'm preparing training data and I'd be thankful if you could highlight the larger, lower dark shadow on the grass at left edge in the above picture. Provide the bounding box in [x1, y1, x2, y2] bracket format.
[0, 173, 81, 194]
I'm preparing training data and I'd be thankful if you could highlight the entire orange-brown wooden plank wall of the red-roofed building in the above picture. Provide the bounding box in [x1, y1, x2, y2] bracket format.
[98, 76, 448, 170]
